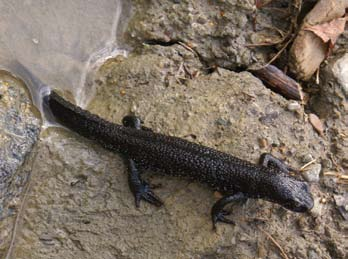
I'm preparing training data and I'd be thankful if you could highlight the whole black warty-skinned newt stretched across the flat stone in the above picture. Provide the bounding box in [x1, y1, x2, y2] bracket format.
[44, 91, 313, 226]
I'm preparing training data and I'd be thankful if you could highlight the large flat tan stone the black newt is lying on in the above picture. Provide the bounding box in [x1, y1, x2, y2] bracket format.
[12, 45, 344, 259]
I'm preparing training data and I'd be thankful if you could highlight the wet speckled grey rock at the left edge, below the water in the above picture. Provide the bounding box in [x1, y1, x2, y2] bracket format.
[0, 71, 41, 257]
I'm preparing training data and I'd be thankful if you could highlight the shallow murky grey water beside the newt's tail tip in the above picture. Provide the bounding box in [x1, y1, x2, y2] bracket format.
[0, 0, 125, 112]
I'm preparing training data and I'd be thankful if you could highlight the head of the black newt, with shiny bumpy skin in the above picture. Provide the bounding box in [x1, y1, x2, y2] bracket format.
[272, 175, 314, 212]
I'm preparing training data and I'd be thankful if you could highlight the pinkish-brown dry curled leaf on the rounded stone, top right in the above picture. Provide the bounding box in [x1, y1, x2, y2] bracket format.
[304, 17, 347, 46]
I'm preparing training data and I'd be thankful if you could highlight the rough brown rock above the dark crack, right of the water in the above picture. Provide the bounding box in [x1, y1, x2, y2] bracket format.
[126, 0, 291, 69]
